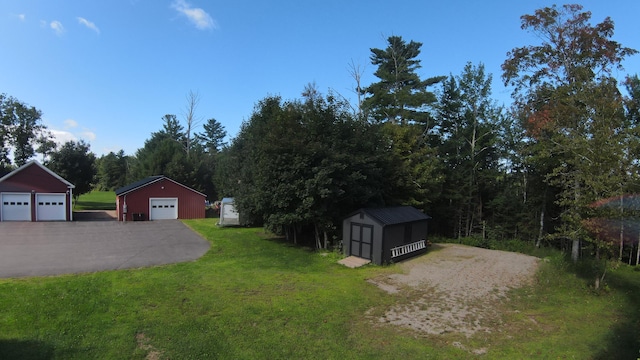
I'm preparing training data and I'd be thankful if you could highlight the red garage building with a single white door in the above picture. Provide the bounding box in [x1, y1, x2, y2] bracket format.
[116, 175, 207, 221]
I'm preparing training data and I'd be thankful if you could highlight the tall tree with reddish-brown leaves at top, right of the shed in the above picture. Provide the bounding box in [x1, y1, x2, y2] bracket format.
[502, 5, 637, 261]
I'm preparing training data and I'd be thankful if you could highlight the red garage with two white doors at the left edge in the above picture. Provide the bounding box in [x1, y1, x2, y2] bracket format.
[0, 160, 75, 221]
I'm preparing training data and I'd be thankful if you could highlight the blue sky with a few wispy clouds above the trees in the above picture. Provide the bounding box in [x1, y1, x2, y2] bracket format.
[0, 0, 640, 155]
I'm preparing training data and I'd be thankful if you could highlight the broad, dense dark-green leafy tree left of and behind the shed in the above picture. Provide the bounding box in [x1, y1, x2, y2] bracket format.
[218, 88, 391, 247]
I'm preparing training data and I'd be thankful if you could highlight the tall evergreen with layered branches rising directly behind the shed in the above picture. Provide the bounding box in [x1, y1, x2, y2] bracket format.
[362, 36, 443, 209]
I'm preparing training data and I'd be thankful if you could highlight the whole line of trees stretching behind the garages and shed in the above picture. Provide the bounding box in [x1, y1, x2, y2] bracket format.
[0, 5, 640, 259]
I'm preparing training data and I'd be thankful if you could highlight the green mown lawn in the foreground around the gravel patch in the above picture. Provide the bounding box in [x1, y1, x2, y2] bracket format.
[0, 219, 640, 359]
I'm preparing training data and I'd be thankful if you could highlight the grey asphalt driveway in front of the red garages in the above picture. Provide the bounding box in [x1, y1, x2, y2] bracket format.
[0, 220, 209, 278]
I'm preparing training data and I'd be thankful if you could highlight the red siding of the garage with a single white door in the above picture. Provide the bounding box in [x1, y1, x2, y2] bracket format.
[116, 179, 205, 221]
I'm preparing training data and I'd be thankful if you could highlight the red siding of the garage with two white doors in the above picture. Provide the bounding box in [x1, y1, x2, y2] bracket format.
[0, 163, 73, 221]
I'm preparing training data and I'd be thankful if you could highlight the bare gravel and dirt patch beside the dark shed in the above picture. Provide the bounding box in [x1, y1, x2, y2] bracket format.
[369, 244, 539, 337]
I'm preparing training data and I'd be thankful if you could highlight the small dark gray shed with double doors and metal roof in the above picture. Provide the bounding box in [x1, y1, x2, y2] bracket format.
[342, 206, 431, 265]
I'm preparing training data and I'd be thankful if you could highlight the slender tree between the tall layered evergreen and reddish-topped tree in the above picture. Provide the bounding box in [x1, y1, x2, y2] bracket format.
[438, 63, 504, 237]
